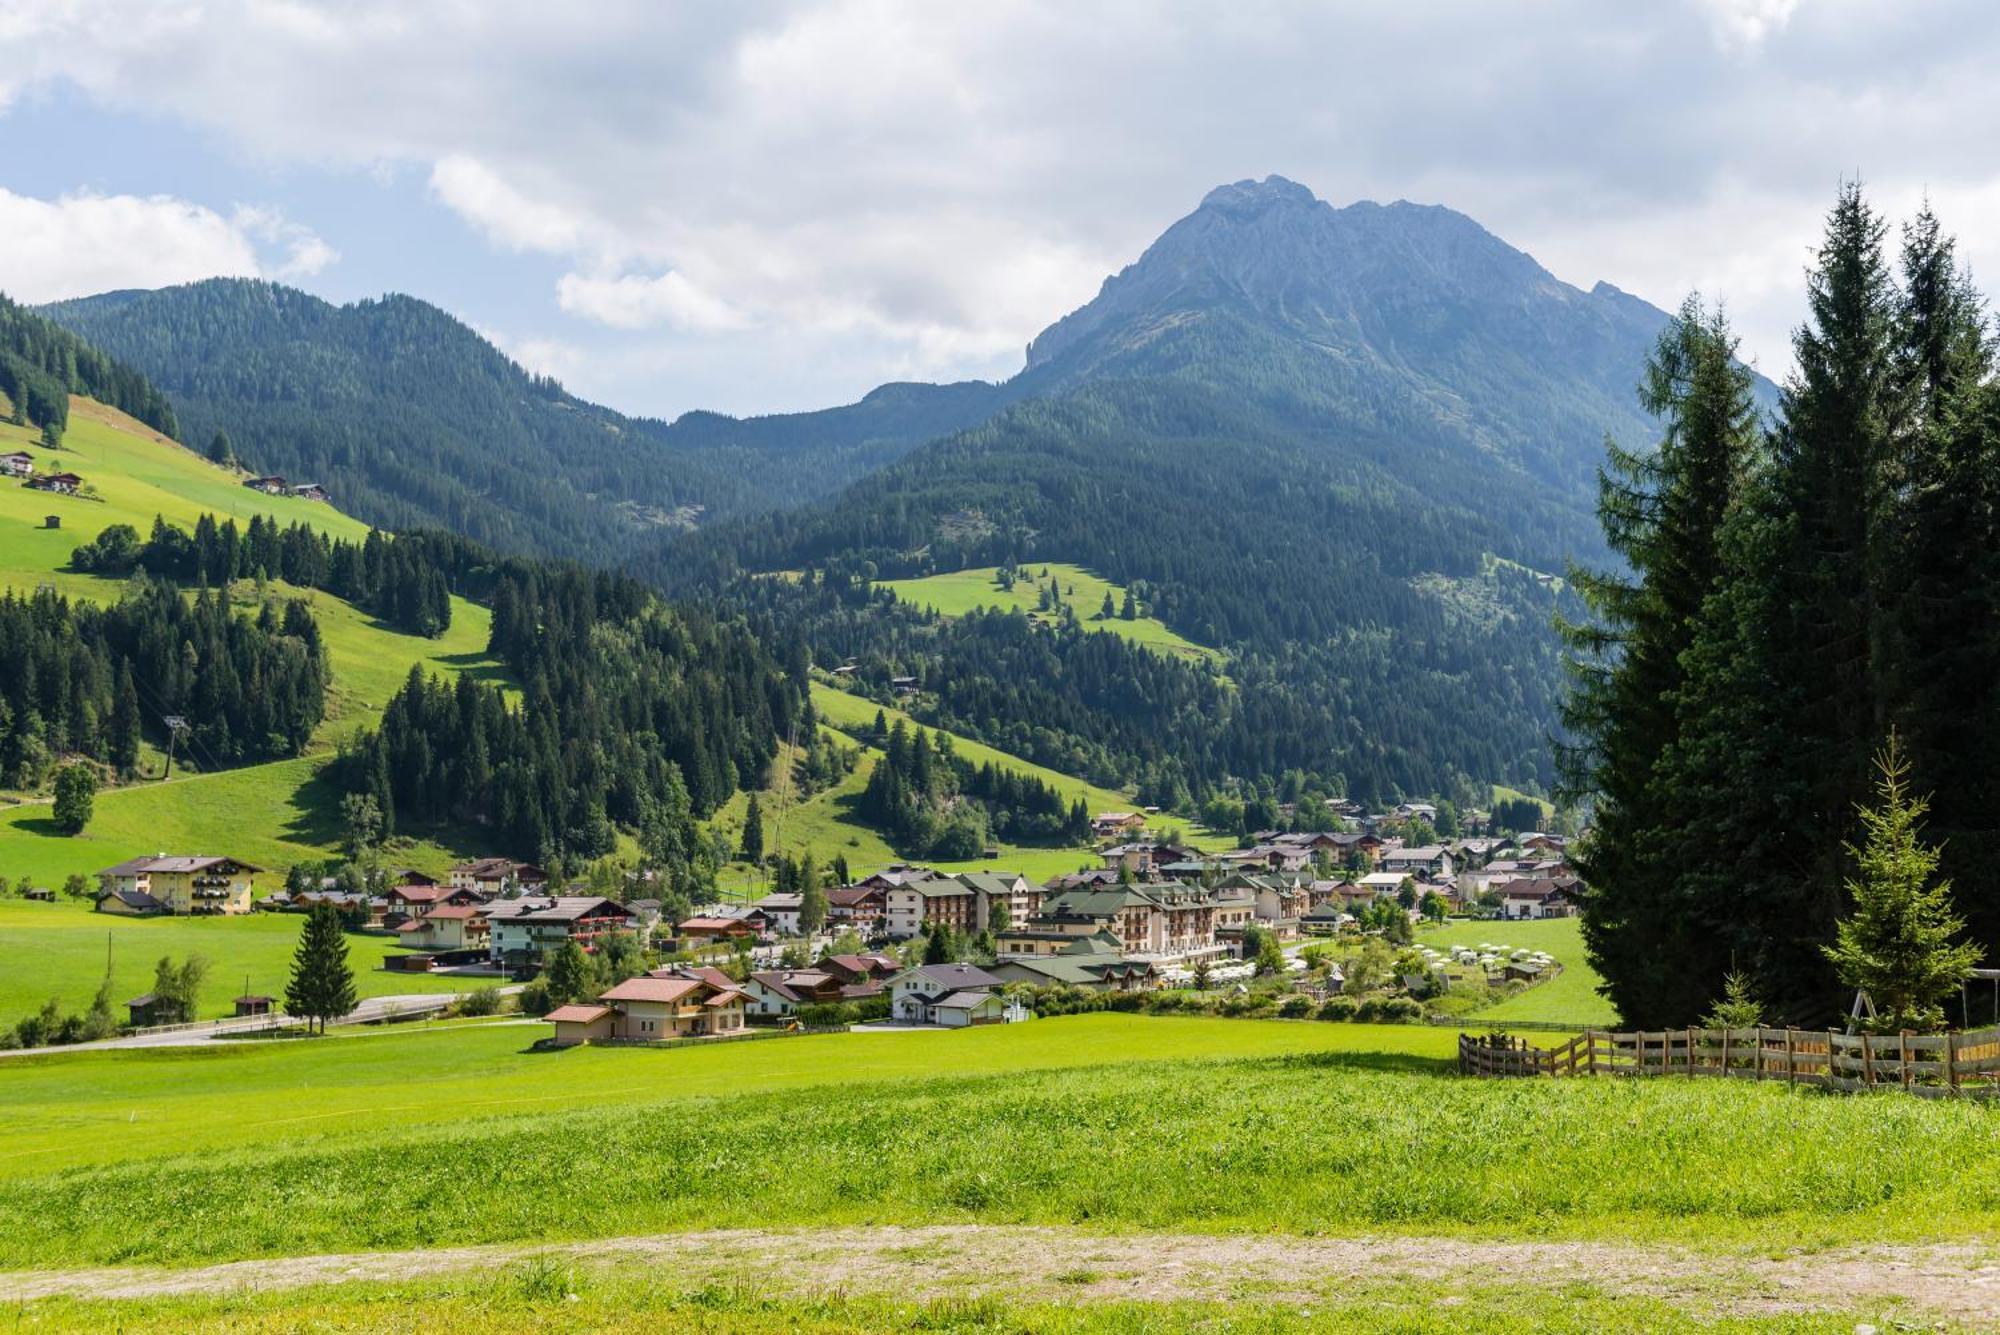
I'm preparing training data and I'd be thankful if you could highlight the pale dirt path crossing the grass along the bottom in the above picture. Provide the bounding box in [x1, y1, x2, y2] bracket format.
[0, 1225, 2000, 1323]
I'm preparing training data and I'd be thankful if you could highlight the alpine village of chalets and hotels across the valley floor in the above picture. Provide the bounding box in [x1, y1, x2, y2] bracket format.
[66, 803, 1582, 1047]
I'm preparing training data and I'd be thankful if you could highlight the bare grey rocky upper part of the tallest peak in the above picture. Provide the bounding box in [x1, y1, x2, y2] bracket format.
[1026, 176, 1696, 486]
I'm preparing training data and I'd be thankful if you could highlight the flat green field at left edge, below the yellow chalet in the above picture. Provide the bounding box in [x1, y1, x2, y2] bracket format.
[0, 899, 470, 1023]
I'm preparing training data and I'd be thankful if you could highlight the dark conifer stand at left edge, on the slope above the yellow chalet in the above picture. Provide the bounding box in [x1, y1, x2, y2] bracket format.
[0, 580, 326, 787]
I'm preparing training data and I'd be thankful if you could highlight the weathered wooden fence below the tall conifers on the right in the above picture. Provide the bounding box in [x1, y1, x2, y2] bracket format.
[1458, 1027, 2000, 1099]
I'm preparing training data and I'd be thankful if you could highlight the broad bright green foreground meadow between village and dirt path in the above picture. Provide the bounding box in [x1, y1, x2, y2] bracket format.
[0, 1015, 2000, 1267]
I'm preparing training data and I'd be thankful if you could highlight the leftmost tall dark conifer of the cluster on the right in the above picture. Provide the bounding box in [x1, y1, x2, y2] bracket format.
[1560, 298, 1756, 1023]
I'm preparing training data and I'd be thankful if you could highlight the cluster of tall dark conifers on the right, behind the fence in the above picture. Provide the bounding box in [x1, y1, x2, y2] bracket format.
[1566, 186, 2000, 1027]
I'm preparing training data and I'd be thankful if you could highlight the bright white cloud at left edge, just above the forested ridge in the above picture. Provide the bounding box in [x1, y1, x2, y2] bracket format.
[0, 190, 336, 302]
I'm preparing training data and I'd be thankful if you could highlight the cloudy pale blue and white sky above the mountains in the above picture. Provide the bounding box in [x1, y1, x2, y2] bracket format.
[0, 0, 2000, 418]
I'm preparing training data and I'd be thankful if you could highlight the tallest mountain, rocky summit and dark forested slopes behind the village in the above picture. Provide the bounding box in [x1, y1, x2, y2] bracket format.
[642, 178, 1768, 803]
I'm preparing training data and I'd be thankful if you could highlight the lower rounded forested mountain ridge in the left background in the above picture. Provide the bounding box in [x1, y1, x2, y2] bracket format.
[44, 278, 1008, 558]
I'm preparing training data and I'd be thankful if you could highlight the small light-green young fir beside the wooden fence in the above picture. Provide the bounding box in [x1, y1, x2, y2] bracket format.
[1824, 733, 1980, 1033]
